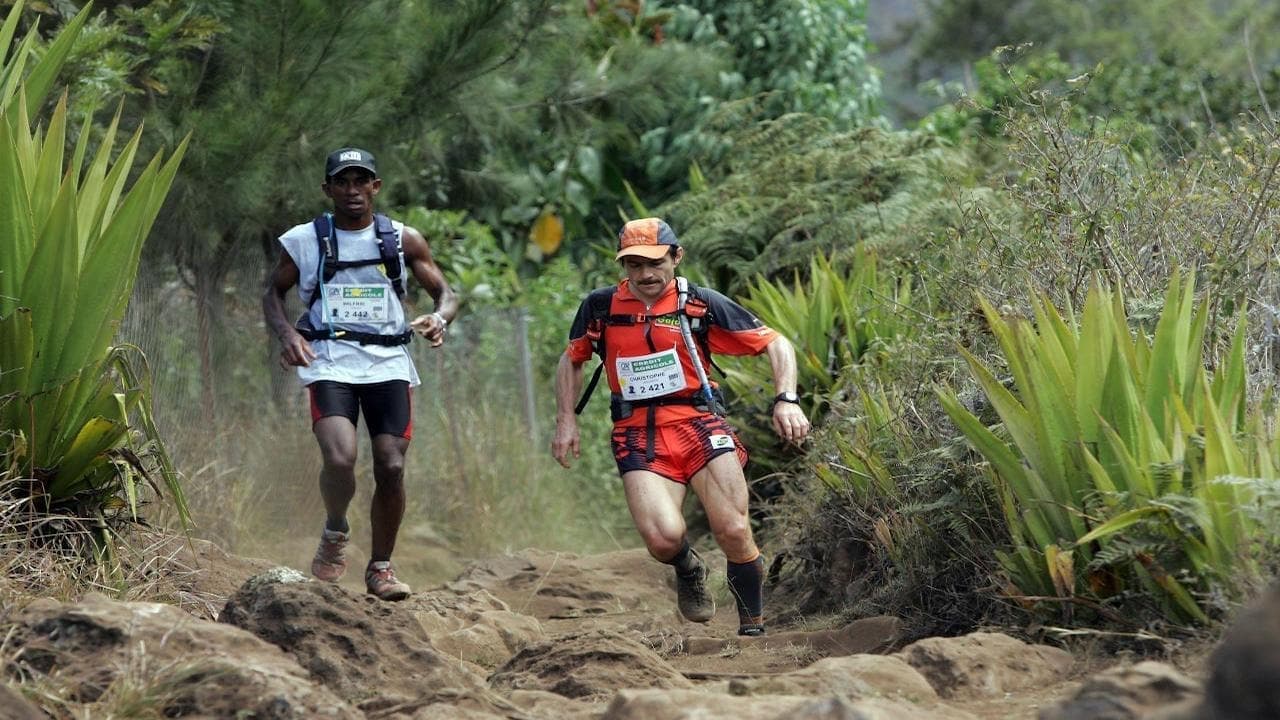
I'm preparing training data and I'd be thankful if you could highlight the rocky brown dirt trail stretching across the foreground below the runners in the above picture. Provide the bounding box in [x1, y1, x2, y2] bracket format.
[0, 544, 1233, 720]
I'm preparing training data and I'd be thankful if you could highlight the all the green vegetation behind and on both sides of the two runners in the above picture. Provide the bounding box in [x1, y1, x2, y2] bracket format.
[0, 9, 1280, 707]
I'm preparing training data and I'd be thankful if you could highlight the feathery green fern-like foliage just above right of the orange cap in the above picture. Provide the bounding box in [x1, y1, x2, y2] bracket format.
[662, 108, 969, 292]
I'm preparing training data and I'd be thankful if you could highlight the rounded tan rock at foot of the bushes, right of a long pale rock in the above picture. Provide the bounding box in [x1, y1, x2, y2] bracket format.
[899, 633, 1071, 698]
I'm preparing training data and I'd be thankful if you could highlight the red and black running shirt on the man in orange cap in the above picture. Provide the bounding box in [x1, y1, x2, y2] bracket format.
[566, 279, 778, 427]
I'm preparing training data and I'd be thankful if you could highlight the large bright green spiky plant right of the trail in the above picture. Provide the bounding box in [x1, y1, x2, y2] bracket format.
[938, 273, 1276, 624]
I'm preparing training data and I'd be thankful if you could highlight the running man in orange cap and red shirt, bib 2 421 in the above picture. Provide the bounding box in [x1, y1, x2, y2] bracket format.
[552, 218, 809, 635]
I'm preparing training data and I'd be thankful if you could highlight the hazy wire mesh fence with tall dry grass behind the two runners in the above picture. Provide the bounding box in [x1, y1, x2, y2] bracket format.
[119, 260, 634, 564]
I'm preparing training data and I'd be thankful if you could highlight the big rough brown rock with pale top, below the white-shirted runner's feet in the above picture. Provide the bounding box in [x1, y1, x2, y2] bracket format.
[219, 568, 501, 712]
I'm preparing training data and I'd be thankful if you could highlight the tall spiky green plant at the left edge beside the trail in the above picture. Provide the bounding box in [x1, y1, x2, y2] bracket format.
[0, 0, 188, 538]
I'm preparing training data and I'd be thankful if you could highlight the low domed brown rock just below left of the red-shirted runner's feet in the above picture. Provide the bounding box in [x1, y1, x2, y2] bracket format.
[489, 630, 692, 698]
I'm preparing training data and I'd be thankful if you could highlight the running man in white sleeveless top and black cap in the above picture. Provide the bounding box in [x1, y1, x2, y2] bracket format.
[262, 147, 458, 601]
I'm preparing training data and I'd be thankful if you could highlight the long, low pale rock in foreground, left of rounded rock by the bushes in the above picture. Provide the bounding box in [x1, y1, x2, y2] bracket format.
[728, 655, 938, 703]
